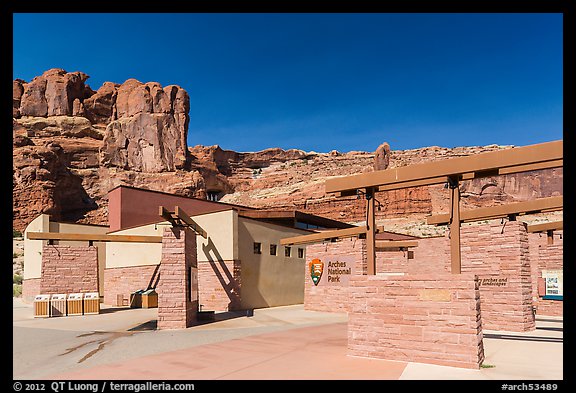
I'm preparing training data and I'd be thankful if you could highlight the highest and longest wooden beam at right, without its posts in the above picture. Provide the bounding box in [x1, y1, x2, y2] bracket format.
[325, 140, 563, 193]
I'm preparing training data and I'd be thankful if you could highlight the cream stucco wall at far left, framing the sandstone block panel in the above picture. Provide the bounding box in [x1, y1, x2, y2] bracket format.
[24, 214, 108, 293]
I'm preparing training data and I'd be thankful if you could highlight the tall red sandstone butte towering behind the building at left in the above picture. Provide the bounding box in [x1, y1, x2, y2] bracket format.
[12, 69, 192, 229]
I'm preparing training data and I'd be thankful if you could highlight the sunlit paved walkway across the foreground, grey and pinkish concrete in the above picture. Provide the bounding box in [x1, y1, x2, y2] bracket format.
[13, 301, 563, 380]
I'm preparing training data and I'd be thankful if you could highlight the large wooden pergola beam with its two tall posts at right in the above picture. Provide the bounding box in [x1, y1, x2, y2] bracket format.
[325, 140, 563, 275]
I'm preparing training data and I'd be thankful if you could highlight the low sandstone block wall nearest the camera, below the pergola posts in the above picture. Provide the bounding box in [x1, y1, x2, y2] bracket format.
[348, 273, 484, 369]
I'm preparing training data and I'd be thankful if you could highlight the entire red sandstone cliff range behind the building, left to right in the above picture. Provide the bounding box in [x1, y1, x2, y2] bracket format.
[12, 69, 563, 234]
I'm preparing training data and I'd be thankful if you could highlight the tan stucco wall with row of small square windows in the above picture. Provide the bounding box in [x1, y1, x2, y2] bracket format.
[238, 217, 308, 309]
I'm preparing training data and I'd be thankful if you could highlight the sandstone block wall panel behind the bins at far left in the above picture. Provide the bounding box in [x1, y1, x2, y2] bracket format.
[40, 245, 98, 294]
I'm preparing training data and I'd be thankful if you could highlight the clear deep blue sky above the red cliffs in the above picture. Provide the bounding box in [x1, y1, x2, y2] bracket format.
[13, 13, 563, 152]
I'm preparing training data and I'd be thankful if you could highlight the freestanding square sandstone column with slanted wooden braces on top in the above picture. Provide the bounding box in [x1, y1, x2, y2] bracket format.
[156, 227, 198, 329]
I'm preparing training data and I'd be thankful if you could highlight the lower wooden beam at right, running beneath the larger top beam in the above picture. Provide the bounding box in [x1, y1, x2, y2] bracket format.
[426, 196, 564, 225]
